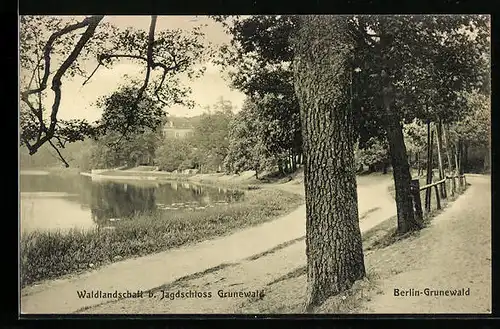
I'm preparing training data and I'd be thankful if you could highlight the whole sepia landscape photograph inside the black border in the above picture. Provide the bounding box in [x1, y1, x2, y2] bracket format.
[18, 14, 492, 317]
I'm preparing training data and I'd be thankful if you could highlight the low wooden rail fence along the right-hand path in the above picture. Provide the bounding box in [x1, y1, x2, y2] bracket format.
[411, 175, 467, 219]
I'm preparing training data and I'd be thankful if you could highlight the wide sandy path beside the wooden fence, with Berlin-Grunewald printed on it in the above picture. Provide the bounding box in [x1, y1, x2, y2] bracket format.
[359, 175, 491, 313]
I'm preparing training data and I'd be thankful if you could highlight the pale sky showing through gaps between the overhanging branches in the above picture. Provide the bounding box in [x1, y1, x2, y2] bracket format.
[33, 16, 244, 121]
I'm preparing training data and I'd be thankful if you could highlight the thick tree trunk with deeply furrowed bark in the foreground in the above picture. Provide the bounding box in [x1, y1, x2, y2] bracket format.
[294, 16, 365, 311]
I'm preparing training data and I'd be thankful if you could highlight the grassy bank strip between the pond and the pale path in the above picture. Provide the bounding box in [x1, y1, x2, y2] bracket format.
[21, 189, 303, 287]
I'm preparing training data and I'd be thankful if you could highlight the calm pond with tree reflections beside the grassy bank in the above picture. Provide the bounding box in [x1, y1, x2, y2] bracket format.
[19, 174, 243, 232]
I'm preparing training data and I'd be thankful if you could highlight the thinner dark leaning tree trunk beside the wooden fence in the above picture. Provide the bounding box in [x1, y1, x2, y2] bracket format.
[380, 29, 423, 234]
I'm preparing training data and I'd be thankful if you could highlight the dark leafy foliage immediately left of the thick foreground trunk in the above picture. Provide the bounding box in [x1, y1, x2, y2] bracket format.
[216, 15, 302, 173]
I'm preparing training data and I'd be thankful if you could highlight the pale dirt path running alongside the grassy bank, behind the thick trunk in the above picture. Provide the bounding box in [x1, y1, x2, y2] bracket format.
[21, 176, 395, 314]
